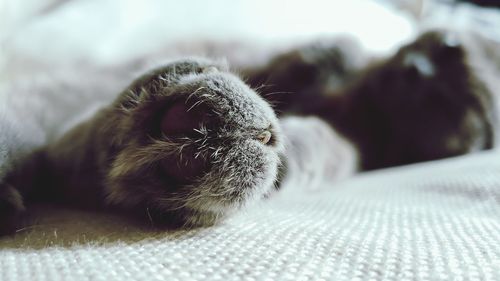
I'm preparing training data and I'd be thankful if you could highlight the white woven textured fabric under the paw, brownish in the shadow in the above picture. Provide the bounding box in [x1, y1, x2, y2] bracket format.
[0, 152, 500, 280]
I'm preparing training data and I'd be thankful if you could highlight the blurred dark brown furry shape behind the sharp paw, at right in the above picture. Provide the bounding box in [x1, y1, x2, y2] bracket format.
[249, 31, 495, 170]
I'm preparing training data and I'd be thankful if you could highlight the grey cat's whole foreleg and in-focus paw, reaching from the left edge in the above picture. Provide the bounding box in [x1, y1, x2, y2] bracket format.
[0, 59, 283, 233]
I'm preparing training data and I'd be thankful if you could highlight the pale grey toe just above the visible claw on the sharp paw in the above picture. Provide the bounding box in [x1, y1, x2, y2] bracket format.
[179, 70, 277, 128]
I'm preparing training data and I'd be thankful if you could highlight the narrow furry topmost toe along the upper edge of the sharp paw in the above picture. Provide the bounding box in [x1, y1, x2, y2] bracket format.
[118, 58, 228, 109]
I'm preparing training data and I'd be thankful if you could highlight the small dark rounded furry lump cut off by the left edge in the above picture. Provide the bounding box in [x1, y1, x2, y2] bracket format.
[0, 183, 25, 235]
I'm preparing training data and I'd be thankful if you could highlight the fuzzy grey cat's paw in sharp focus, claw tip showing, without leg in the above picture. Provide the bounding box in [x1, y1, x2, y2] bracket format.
[100, 60, 282, 225]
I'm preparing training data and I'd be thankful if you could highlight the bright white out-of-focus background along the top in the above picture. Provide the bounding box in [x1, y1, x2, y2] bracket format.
[0, 0, 500, 73]
